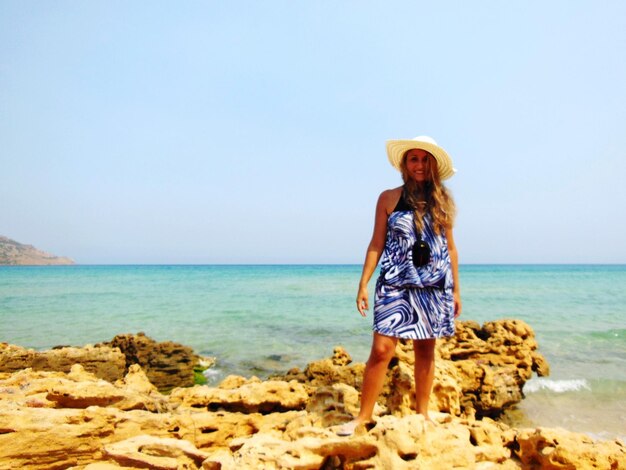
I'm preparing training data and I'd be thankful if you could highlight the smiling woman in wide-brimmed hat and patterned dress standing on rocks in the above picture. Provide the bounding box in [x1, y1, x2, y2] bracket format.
[337, 136, 461, 436]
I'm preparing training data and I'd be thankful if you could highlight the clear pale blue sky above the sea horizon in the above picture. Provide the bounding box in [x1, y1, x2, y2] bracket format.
[0, 0, 626, 263]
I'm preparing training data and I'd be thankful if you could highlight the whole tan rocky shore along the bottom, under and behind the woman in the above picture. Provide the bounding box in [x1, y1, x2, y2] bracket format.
[0, 320, 626, 470]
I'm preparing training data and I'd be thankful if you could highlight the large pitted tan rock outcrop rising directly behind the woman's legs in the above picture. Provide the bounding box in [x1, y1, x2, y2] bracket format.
[275, 320, 549, 417]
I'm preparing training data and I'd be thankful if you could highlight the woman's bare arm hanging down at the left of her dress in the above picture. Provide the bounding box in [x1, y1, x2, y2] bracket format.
[356, 190, 390, 316]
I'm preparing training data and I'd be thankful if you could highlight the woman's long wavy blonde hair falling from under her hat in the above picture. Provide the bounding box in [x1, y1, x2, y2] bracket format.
[400, 153, 456, 235]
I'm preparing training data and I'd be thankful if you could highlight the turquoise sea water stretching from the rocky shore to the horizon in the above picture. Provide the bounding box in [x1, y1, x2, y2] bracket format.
[0, 265, 626, 437]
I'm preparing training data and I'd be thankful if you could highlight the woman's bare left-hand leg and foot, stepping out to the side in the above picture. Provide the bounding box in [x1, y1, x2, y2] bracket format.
[338, 332, 398, 436]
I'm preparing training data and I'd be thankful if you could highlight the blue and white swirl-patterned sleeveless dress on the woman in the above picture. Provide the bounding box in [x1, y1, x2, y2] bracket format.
[373, 193, 454, 339]
